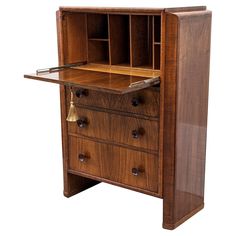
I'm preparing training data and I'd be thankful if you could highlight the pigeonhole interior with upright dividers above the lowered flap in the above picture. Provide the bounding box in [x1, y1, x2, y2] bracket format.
[65, 13, 162, 71]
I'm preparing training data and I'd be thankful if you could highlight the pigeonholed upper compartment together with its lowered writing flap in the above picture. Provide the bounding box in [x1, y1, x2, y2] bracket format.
[25, 12, 161, 94]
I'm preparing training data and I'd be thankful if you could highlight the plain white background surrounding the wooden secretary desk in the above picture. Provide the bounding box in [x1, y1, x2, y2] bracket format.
[0, 0, 236, 236]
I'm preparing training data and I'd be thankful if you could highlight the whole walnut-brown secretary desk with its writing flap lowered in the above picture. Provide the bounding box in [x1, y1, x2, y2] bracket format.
[25, 6, 211, 229]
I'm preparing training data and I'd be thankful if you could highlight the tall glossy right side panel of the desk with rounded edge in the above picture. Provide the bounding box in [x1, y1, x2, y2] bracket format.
[163, 11, 211, 229]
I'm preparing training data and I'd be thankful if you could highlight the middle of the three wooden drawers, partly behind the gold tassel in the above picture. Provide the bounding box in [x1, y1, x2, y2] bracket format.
[68, 108, 159, 151]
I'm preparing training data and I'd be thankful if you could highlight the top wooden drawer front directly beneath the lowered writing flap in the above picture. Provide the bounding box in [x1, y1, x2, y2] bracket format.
[67, 87, 160, 117]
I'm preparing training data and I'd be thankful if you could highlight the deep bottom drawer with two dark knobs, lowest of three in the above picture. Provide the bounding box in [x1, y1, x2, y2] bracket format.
[69, 136, 161, 193]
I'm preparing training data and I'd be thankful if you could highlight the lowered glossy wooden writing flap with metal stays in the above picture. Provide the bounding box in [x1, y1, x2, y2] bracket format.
[25, 68, 159, 94]
